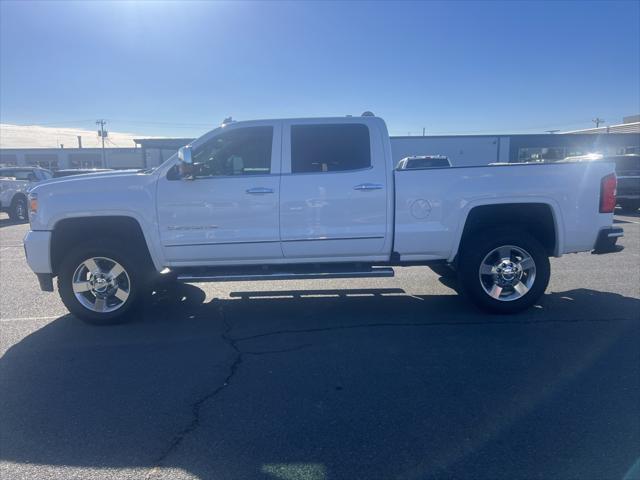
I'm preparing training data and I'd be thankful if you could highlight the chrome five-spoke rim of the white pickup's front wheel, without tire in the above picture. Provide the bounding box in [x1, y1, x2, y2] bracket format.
[72, 257, 131, 313]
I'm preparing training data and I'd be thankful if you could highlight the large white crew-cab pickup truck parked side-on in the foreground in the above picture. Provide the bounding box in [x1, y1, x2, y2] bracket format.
[24, 116, 622, 323]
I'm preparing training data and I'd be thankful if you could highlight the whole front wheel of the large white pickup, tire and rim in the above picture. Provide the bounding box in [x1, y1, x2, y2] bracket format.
[58, 241, 143, 324]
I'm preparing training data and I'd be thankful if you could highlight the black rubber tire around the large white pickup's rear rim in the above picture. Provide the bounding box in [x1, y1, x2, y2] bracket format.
[458, 229, 551, 314]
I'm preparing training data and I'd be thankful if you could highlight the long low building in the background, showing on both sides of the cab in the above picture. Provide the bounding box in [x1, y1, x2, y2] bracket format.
[0, 116, 640, 170]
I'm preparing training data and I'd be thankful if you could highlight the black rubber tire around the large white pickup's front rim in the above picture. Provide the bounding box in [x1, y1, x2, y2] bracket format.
[58, 239, 148, 325]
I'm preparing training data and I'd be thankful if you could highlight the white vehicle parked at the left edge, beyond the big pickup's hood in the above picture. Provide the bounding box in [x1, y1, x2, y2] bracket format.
[0, 167, 52, 222]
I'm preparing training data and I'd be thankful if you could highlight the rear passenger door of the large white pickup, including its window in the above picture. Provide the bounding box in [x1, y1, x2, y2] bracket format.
[280, 119, 392, 261]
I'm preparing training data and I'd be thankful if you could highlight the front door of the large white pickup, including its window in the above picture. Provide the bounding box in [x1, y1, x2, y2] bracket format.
[158, 122, 282, 265]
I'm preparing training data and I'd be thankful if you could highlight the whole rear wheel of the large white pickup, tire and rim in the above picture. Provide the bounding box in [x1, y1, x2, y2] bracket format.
[458, 229, 551, 313]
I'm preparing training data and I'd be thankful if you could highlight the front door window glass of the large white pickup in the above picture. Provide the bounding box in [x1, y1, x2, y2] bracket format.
[193, 127, 273, 177]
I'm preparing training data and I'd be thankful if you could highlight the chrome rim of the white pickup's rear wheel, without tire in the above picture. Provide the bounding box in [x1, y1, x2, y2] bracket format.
[479, 245, 536, 302]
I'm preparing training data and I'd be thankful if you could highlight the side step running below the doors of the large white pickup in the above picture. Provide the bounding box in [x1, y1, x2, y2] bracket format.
[174, 264, 394, 283]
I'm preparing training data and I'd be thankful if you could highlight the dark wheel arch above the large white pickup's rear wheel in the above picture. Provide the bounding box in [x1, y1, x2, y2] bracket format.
[448, 198, 564, 262]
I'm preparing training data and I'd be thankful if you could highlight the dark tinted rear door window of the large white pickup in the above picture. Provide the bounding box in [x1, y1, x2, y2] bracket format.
[291, 124, 371, 173]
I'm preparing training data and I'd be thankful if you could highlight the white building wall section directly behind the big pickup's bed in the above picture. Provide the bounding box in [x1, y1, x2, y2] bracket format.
[391, 136, 509, 167]
